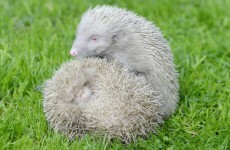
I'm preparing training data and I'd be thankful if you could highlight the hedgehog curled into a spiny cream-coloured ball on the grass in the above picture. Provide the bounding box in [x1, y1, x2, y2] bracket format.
[43, 57, 163, 143]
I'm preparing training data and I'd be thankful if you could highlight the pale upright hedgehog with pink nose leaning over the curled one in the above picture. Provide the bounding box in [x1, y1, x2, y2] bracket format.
[70, 5, 179, 118]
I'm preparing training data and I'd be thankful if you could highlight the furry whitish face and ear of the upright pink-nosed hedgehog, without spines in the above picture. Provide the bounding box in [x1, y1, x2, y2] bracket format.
[70, 22, 126, 57]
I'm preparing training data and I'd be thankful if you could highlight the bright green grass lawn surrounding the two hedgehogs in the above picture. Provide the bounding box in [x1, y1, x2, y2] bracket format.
[0, 0, 230, 150]
